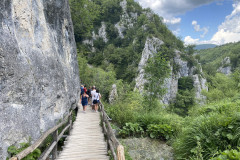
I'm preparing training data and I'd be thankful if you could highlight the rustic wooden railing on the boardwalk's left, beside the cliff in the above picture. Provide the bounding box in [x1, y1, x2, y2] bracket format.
[10, 111, 72, 160]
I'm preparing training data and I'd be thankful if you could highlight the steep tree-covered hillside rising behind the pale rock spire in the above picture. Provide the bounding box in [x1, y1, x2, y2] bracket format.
[71, 0, 184, 83]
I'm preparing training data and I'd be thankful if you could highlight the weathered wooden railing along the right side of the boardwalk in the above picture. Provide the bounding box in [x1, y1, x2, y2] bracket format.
[99, 102, 125, 160]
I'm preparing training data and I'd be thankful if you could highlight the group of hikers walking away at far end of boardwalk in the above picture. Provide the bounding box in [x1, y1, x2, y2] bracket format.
[80, 85, 101, 113]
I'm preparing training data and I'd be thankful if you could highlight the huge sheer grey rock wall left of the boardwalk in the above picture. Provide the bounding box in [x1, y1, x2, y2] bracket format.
[0, 0, 80, 159]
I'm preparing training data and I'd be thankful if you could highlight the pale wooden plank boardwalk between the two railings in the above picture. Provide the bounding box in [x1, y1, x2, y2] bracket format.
[57, 106, 109, 160]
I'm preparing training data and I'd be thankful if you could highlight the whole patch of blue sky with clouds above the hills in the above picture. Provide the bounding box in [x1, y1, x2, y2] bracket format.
[136, 0, 240, 45]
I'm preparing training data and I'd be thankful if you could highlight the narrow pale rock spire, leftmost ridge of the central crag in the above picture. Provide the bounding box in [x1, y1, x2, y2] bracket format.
[135, 37, 163, 92]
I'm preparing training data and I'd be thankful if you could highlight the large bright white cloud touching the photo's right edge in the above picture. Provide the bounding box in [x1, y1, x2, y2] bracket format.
[211, 1, 240, 44]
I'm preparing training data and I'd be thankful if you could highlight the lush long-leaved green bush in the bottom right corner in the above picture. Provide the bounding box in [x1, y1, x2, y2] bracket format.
[173, 112, 240, 159]
